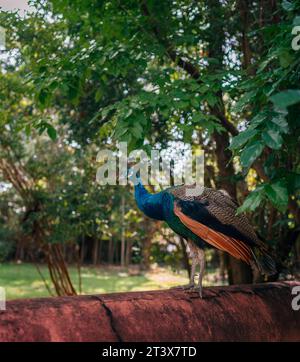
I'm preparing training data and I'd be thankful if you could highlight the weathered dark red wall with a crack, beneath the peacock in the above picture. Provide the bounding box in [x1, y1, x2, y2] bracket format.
[0, 282, 300, 342]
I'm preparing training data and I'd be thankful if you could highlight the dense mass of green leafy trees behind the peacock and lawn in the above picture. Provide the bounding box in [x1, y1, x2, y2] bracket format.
[0, 0, 300, 294]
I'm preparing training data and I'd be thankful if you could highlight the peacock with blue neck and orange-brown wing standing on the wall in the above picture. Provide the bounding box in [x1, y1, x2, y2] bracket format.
[134, 177, 277, 298]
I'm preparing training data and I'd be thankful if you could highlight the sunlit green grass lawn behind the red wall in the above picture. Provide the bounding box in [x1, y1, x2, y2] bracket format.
[0, 263, 222, 299]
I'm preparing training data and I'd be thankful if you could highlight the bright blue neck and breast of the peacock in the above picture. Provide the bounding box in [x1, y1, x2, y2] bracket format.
[134, 181, 164, 220]
